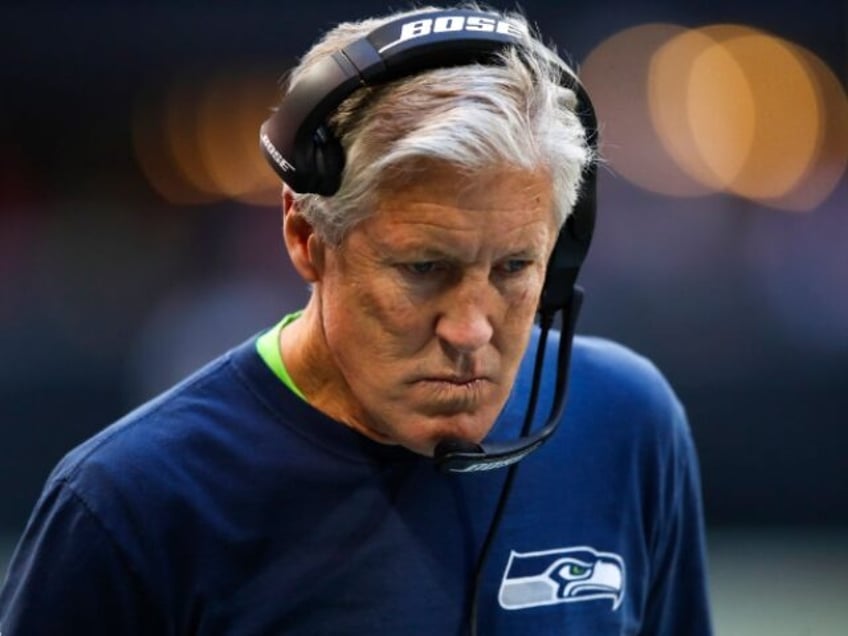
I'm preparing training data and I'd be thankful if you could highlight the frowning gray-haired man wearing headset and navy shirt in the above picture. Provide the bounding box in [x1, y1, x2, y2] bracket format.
[0, 2, 710, 636]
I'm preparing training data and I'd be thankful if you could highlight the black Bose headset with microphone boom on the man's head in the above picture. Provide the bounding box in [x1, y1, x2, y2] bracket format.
[259, 4, 598, 472]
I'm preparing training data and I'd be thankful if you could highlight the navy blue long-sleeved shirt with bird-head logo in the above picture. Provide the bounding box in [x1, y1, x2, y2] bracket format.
[0, 330, 711, 636]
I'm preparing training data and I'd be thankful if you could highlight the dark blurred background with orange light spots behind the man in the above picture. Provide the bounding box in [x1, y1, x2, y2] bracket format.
[0, 0, 848, 636]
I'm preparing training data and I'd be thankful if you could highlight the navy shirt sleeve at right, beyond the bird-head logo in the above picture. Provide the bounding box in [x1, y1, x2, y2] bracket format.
[641, 403, 713, 636]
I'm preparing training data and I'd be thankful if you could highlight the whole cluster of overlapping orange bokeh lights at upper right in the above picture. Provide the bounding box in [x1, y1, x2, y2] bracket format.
[582, 24, 848, 210]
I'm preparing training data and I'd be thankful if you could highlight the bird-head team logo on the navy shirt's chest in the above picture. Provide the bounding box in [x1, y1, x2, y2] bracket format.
[498, 546, 624, 610]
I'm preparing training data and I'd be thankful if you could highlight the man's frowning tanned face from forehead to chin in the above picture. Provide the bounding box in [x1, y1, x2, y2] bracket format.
[288, 161, 557, 455]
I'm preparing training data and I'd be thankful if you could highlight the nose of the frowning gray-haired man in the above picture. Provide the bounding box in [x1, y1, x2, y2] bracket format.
[436, 281, 494, 354]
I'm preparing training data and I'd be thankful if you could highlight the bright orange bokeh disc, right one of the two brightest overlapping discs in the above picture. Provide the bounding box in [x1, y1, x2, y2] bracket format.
[689, 26, 822, 200]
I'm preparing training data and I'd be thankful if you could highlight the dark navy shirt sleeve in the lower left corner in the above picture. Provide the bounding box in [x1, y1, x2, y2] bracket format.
[0, 481, 165, 636]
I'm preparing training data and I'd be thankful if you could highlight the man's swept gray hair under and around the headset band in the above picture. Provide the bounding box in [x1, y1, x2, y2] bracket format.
[289, 3, 594, 244]
